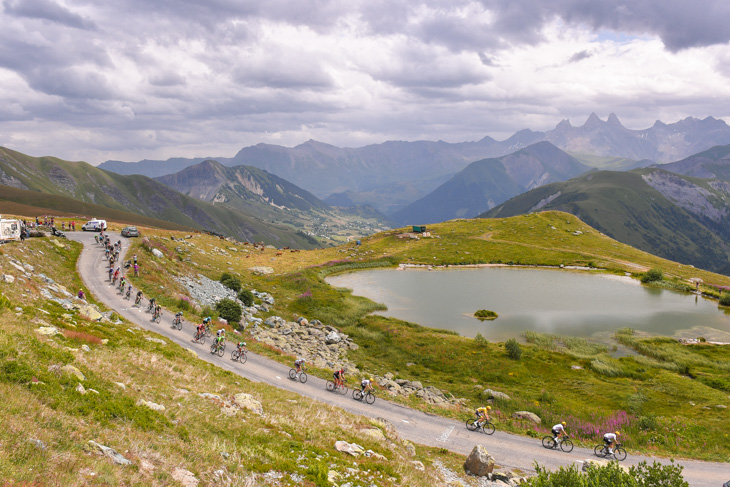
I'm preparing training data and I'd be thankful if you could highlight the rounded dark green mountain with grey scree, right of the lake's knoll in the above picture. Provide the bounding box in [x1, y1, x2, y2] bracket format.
[482, 169, 730, 274]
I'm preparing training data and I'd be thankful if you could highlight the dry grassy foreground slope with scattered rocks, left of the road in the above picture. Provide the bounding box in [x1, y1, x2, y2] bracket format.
[0, 239, 459, 486]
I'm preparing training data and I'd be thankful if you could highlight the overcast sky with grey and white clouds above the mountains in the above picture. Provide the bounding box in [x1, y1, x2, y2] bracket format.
[0, 0, 730, 164]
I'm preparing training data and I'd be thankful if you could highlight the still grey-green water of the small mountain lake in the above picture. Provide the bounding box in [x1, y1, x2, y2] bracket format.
[327, 267, 730, 341]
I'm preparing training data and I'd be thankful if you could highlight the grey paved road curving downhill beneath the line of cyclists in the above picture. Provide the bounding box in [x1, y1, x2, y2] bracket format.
[67, 232, 730, 487]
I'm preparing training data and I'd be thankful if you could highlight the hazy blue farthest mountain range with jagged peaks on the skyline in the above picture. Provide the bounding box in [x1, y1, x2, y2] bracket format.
[99, 114, 730, 215]
